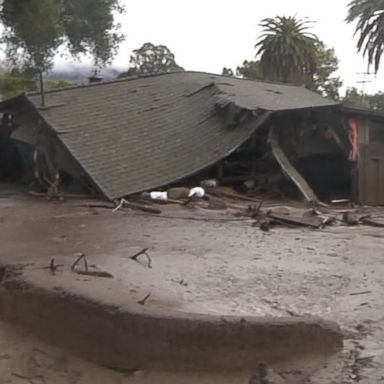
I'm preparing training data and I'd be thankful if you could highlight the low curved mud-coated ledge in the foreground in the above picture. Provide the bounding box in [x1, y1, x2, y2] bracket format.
[0, 268, 342, 370]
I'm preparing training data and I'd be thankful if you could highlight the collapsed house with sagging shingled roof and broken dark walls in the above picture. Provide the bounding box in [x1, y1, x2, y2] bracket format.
[0, 72, 384, 204]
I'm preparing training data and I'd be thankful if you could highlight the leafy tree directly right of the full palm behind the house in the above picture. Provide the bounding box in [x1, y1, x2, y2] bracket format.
[310, 41, 343, 100]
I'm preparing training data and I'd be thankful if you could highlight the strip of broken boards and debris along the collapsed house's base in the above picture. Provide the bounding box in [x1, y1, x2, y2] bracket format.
[78, 180, 384, 232]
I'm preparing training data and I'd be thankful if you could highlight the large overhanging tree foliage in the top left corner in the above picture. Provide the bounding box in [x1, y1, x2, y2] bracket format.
[0, 0, 122, 71]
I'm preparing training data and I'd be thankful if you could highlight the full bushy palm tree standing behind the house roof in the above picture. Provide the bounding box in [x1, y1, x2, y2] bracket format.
[255, 16, 318, 86]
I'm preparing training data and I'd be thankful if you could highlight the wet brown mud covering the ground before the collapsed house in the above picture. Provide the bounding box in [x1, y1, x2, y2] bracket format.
[0, 189, 384, 384]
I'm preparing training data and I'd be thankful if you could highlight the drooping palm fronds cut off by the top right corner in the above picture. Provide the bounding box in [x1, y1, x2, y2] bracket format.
[346, 0, 384, 73]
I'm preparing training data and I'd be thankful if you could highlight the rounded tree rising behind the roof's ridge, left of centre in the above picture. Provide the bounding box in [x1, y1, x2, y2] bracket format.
[118, 43, 183, 78]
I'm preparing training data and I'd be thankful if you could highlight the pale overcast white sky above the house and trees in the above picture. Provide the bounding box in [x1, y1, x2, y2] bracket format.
[58, 0, 384, 93]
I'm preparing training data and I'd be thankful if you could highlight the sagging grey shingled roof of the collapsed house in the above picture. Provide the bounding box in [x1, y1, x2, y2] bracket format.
[18, 72, 336, 199]
